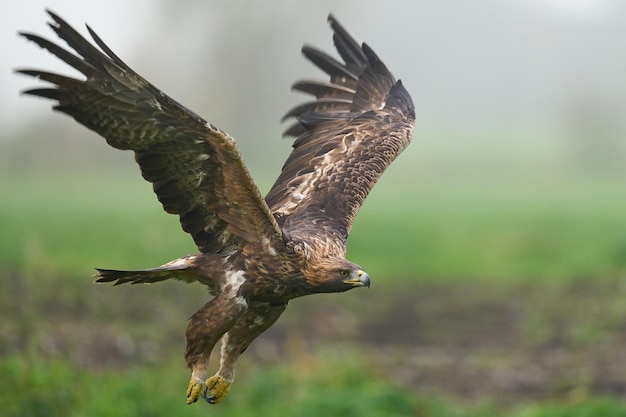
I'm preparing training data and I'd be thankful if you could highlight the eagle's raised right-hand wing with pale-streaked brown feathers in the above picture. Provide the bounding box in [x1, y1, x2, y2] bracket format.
[265, 16, 415, 255]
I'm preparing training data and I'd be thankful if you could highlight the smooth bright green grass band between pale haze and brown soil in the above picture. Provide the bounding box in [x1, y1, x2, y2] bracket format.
[0, 174, 626, 282]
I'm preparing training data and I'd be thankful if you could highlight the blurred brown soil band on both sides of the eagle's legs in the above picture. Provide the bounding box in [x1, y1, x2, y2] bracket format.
[0, 275, 626, 404]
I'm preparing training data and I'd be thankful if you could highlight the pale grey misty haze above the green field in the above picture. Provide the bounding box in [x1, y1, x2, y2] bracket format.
[0, 0, 626, 187]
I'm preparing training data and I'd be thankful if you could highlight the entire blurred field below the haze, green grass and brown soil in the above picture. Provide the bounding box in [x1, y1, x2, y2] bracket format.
[0, 172, 626, 417]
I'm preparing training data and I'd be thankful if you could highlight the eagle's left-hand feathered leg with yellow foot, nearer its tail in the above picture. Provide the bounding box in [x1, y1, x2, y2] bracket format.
[185, 293, 248, 404]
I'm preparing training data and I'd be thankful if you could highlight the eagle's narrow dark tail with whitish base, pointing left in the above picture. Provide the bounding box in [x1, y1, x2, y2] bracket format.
[96, 255, 197, 285]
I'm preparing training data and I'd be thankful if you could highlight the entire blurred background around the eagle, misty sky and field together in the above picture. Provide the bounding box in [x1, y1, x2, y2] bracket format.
[0, 0, 626, 417]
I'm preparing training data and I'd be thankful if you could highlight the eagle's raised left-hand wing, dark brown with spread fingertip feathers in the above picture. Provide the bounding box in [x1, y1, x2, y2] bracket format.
[18, 12, 282, 253]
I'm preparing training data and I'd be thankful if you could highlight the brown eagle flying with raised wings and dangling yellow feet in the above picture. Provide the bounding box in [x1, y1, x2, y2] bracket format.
[17, 11, 415, 404]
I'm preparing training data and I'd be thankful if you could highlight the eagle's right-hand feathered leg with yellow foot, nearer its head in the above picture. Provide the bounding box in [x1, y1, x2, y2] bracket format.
[202, 303, 287, 404]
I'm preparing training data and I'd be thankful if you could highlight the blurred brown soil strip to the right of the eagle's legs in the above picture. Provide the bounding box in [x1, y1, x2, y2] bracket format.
[254, 282, 626, 404]
